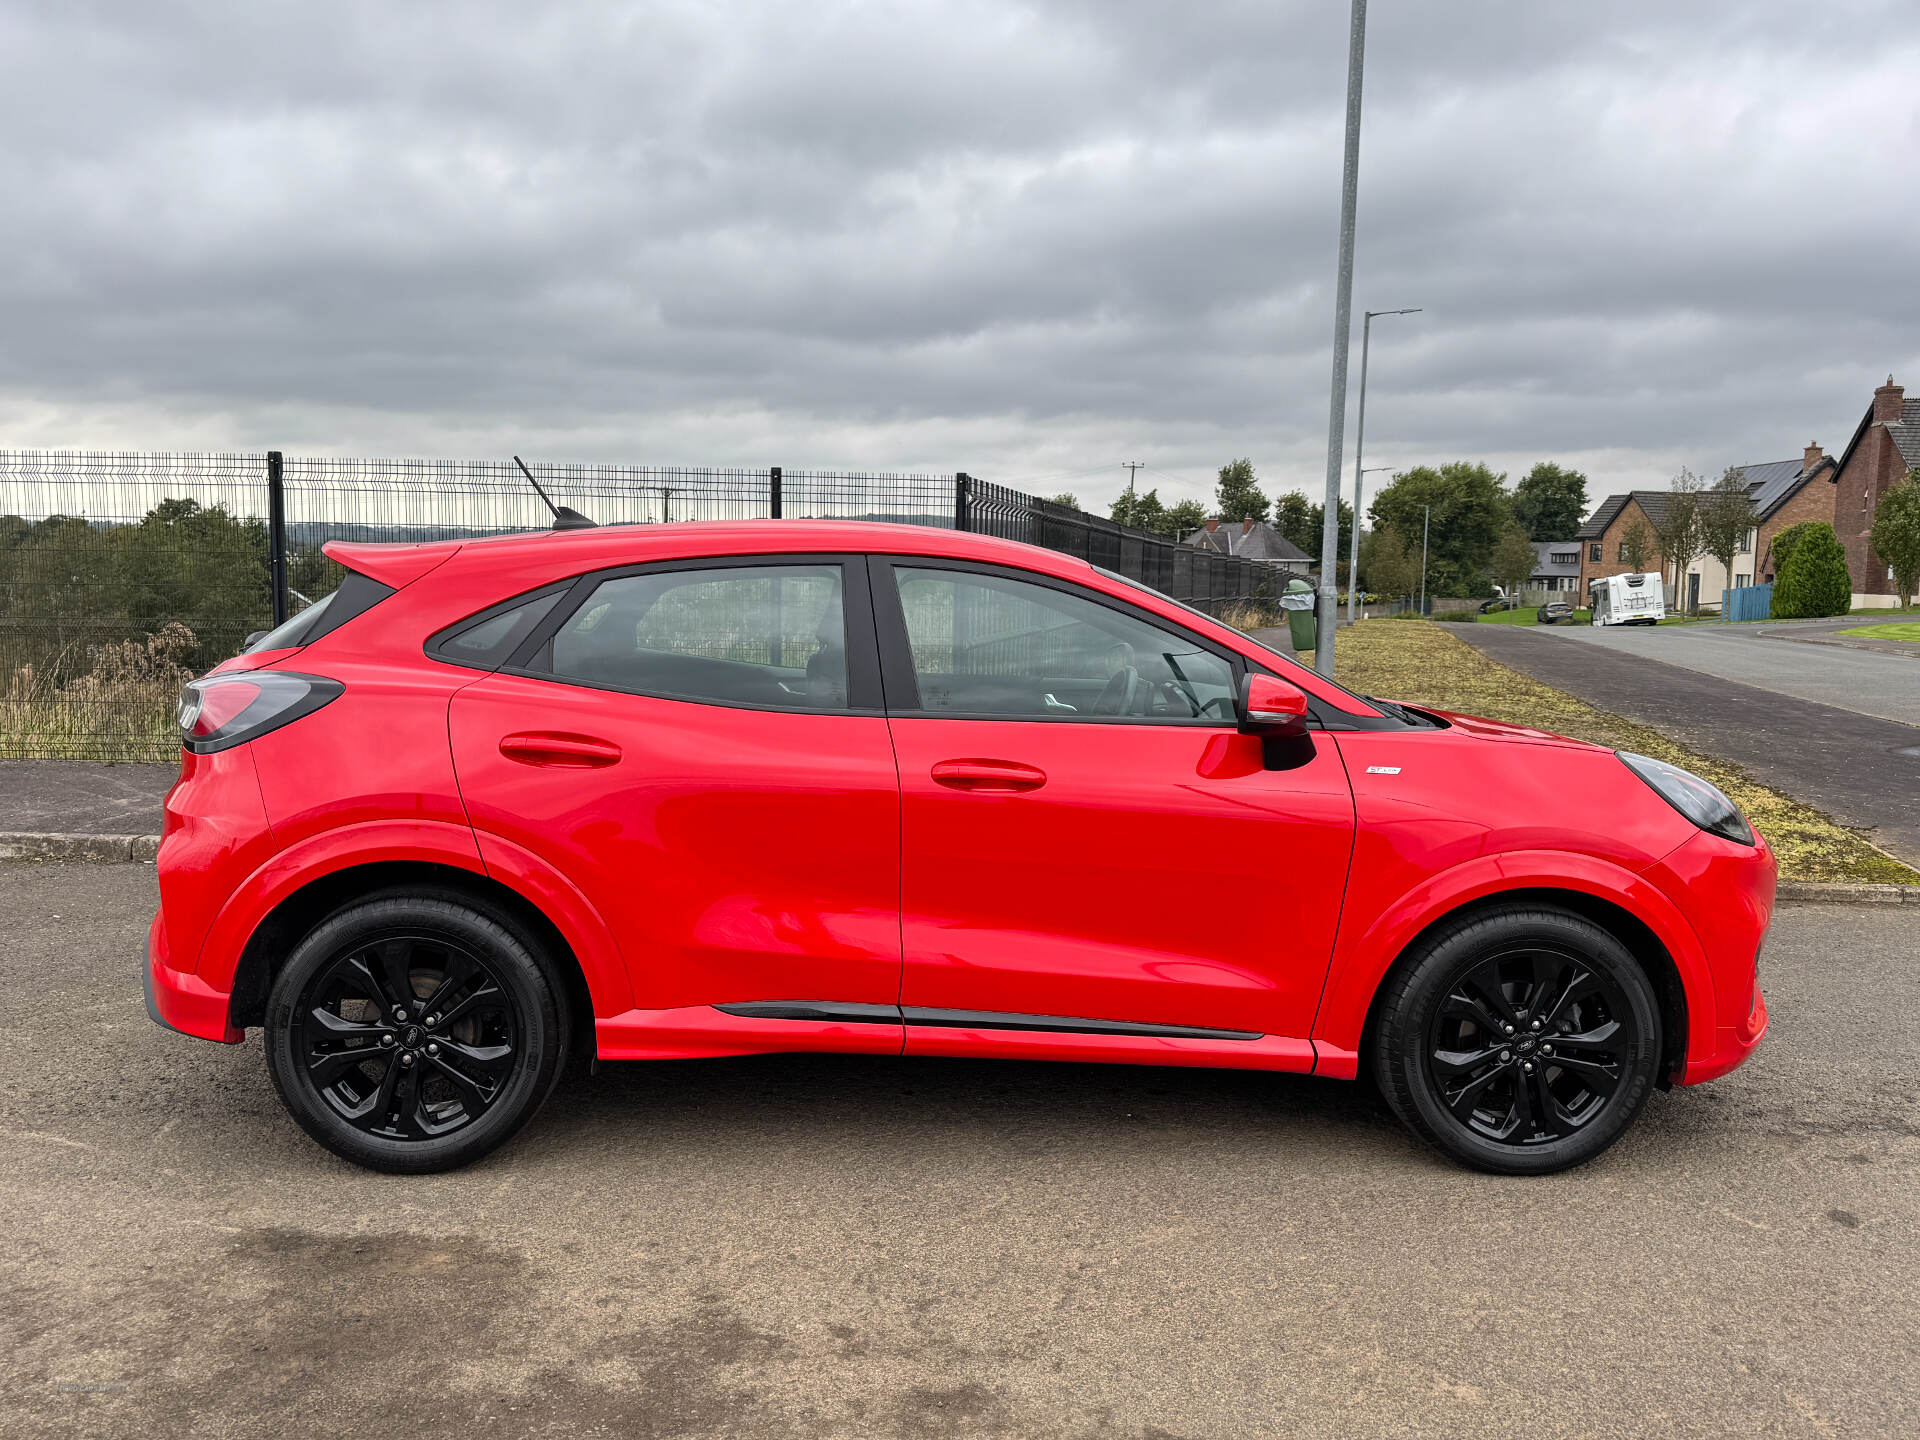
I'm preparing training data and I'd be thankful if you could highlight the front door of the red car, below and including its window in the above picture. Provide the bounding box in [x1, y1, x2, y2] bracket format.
[874, 559, 1354, 1052]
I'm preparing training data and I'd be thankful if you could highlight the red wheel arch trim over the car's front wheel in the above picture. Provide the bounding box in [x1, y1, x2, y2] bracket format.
[1313, 851, 1716, 1079]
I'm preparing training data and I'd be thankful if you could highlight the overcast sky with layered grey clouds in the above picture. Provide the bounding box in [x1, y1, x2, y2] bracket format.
[0, 0, 1920, 518]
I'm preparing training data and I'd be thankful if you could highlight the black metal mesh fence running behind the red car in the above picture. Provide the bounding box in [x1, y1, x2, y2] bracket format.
[0, 451, 1284, 760]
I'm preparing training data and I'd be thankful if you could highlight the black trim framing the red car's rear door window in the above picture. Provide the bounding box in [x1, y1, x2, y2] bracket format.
[483, 551, 887, 716]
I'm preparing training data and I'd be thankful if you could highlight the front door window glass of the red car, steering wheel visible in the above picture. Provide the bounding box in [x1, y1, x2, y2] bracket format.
[893, 566, 1235, 724]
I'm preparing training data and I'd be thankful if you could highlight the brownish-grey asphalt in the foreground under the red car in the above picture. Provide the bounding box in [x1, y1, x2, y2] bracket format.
[0, 866, 1920, 1440]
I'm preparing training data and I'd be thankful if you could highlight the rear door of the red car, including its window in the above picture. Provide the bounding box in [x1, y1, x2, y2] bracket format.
[440, 557, 900, 1021]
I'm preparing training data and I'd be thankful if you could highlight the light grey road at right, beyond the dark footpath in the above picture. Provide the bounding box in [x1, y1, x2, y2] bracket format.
[1497, 616, 1920, 726]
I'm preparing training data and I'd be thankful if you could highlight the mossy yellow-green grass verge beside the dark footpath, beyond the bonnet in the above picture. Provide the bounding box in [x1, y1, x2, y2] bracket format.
[1334, 620, 1920, 885]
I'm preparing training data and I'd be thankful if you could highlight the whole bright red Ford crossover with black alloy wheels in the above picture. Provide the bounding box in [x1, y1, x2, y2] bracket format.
[146, 520, 1774, 1173]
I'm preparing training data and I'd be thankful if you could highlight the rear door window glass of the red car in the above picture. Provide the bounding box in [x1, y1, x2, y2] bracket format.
[532, 564, 847, 710]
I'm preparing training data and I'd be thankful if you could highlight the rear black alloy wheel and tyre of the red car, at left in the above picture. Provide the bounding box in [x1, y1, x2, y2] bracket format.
[267, 891, 566, 1175]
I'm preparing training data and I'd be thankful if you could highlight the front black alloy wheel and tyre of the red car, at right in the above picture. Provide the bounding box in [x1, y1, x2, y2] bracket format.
[1373, 906, 1661, 1175]
